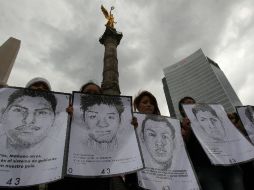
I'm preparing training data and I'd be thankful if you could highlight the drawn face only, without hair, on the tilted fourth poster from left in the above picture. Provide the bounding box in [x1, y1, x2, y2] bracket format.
[196, 110, 226, 140]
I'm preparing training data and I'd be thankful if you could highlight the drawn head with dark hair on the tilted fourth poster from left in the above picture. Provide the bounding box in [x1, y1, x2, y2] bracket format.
[192, 104, 226, 141]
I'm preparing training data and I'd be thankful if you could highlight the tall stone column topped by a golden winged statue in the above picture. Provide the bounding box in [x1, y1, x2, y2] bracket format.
[99, 6, 123, 95]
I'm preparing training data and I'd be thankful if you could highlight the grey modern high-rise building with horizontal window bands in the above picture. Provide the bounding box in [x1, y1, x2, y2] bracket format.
[162, 49, 242, 118]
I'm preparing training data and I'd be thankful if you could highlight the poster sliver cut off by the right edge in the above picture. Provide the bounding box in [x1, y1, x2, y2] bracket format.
[236, 106, 254, 144]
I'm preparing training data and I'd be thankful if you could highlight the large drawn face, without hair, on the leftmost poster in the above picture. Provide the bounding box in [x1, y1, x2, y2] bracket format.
[3, 96, 55, 147]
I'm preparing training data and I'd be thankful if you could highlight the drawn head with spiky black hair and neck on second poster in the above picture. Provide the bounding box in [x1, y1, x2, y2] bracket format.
[80, 95, 124, 152]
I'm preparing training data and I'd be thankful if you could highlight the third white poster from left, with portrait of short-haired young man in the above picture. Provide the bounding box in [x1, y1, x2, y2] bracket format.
[135, 113, 199, 190]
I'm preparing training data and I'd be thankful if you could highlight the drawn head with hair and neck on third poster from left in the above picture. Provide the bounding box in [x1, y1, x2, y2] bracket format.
[140, 115, 175, 170]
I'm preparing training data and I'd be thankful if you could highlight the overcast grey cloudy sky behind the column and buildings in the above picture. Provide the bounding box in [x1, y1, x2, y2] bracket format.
[0, 0, 254, 115]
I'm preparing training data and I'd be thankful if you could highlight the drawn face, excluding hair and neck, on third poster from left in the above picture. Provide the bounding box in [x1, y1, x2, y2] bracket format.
[143, 120, 174, 164]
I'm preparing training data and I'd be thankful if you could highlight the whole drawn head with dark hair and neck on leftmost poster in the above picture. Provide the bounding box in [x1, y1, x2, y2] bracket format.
[1, 89, 57, 153]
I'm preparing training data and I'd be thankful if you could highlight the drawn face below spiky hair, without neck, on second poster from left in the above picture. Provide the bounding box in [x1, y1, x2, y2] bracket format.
[84, 104, 120, 143]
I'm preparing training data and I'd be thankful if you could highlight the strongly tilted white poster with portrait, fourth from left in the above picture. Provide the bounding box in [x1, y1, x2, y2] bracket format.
[183, 104, 254, 165]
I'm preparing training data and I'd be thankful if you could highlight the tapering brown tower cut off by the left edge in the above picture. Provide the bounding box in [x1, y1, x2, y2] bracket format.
[0, 37, 21, 85]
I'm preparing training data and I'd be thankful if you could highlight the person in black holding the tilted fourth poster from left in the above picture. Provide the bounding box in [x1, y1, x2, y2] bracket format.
[179, 97, 244, 190]
